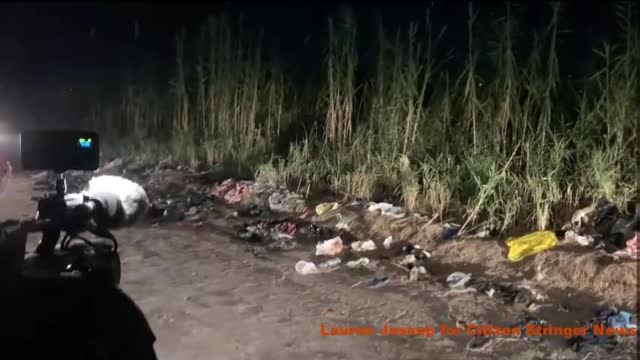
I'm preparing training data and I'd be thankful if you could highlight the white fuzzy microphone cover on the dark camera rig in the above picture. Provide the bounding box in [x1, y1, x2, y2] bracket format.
[82, 175, 150, 227]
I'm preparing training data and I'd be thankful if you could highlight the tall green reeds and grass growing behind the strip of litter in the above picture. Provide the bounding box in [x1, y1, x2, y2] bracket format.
[91, 4, 640, 229]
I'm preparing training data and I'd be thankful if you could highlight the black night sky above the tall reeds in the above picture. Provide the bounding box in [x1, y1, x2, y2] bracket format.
[0, 1, 615, 131]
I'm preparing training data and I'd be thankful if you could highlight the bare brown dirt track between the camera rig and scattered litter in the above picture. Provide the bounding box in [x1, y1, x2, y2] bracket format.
[0, 176, 632, 360]
